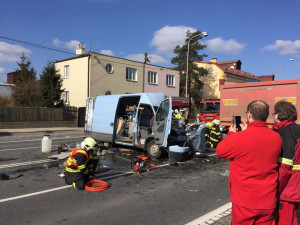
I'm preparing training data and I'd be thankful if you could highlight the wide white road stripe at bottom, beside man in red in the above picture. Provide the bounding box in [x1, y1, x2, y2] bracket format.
[186, 202, 232, 225]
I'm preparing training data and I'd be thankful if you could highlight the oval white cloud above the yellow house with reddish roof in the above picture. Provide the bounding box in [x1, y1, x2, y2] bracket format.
[205, 37, 246, 54]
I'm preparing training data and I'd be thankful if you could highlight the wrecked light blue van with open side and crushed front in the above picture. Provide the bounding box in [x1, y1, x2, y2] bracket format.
[85, 93, 187, 158]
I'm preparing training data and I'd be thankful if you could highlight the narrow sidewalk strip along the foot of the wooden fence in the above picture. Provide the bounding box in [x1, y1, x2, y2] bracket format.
[0, 127, 84, 133]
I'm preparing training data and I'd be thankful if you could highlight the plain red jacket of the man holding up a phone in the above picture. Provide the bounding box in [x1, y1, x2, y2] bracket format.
[217, 122, 281, 209]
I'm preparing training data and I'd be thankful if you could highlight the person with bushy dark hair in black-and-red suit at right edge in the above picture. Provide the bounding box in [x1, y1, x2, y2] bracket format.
[272, 101, 300, 225]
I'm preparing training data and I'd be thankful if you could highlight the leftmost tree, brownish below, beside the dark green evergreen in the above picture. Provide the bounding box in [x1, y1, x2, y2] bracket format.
[12, 54, 38, 107]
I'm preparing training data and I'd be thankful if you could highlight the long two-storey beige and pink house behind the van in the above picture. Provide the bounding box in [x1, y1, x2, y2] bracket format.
[55, 45, 179, 107]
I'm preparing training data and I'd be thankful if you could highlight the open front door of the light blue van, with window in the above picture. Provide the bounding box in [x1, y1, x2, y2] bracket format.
[152, 98, 172, 147]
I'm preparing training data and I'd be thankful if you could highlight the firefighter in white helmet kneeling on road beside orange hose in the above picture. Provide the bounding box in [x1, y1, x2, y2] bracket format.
[65, 137, 99, 190]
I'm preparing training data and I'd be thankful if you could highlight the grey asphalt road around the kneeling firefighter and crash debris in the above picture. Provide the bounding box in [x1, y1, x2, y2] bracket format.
[0, 131, 229, 225]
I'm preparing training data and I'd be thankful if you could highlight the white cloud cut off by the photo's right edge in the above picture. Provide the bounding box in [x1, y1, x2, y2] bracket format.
[262, 40, 300, 55]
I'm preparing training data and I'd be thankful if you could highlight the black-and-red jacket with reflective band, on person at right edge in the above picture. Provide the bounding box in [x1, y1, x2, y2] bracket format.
[274, 120, 300, 202]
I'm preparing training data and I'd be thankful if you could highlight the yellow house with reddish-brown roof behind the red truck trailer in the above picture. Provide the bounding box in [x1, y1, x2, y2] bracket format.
[193, 58, 275, 99]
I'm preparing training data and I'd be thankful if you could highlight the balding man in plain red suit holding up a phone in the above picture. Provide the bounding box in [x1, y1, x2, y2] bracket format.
[217, 100, 281, 225]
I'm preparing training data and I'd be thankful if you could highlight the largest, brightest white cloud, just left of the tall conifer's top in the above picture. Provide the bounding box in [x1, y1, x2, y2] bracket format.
[150, 26, 197, 55]
